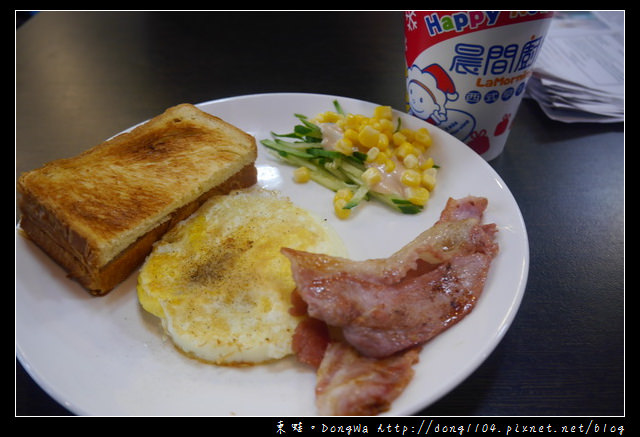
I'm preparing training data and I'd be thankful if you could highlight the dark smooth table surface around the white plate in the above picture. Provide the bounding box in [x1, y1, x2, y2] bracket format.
[15, 12, 625, 416]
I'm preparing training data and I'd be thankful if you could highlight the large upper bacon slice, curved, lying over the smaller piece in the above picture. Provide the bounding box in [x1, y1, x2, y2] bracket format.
[282, 197, 498, 358]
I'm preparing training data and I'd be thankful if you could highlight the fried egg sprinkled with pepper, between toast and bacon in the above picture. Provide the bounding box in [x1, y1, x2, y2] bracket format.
[137, 188, 346, 365]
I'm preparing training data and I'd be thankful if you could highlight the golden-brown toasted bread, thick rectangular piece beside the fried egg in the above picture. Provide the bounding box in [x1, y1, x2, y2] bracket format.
[18, 104, 257, 295]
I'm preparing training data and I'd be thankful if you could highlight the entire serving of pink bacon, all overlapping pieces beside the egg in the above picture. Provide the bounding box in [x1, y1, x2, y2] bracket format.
[282, 197, 498, 416]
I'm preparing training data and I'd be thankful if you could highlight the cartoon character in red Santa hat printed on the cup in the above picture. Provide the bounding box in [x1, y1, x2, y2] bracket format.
[407, 64, 476, 141]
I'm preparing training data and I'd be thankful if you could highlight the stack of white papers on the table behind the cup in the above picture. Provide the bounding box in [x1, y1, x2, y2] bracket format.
[527, 11, 624, 123]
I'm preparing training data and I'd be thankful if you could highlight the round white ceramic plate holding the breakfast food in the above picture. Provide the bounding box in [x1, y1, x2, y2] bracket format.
[15, 93, 529, 416]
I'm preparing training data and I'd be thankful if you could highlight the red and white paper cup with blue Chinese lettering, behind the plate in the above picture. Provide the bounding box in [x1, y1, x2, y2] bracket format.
[405, 11, 553, 161]
